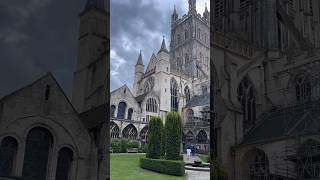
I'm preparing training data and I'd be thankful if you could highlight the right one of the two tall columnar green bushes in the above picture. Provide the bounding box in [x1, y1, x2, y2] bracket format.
[165, 112, 182, 160]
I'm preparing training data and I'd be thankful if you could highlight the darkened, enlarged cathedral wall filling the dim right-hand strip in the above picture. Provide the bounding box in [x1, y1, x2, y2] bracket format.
[210, 0, 320, 180]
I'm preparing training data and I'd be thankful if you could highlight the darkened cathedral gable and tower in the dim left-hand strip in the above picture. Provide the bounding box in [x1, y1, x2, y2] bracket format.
[0, 0, 109, 180]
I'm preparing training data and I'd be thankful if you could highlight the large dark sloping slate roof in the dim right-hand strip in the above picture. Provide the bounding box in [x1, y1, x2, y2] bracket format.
[242, 100, 320, 144]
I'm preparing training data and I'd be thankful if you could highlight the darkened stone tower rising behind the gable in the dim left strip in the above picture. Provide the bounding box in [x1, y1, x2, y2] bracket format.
[72, 0, 109, 113]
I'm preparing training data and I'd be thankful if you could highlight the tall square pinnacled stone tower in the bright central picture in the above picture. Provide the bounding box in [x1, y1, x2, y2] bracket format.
[170, 0, 210, 78]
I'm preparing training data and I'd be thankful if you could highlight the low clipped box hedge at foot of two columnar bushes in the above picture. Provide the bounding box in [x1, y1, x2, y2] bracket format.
[140, 158, 185, 176]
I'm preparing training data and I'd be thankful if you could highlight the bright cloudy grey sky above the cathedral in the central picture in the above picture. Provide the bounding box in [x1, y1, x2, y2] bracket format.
[110, 0, 210, 90]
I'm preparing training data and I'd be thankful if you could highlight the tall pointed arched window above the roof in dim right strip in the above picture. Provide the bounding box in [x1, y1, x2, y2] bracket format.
[238, 76, 256, 131]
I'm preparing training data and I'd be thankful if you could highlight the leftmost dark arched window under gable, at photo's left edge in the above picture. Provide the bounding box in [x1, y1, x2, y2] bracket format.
[0, 137, 18, 177]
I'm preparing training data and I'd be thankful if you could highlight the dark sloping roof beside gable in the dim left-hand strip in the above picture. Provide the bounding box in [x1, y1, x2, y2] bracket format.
[79, 104, 109, 129]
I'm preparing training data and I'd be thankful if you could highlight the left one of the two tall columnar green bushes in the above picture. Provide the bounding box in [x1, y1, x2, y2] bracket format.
[146, 117, 162, 159]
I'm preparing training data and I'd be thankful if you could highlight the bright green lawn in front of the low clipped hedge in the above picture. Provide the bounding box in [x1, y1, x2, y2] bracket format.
[110, 154, 185, 180]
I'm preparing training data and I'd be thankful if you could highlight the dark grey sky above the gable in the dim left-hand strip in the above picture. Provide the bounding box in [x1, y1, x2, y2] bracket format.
[0, 0, 86, 97]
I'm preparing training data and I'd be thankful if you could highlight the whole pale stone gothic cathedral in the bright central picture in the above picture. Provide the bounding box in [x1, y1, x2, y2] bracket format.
[110, 0, 210, 153]
